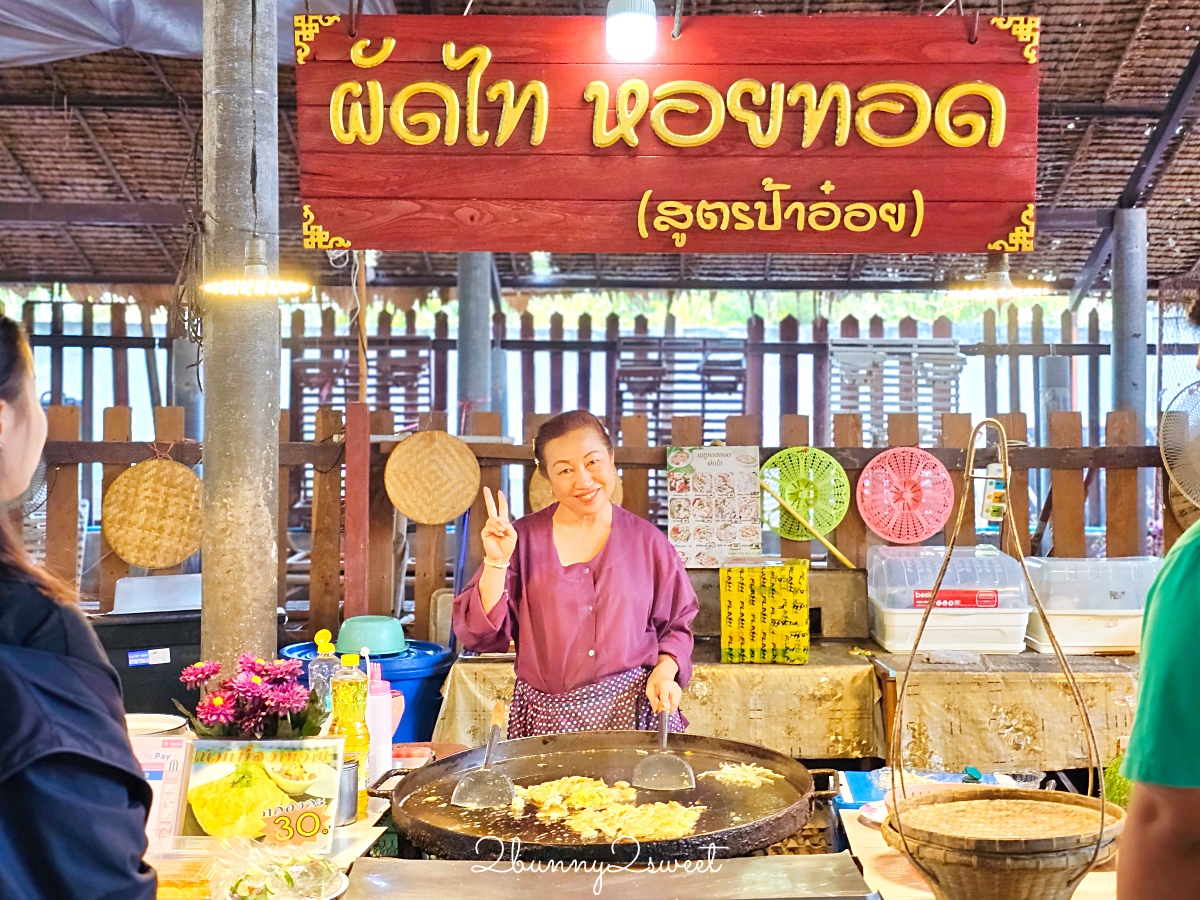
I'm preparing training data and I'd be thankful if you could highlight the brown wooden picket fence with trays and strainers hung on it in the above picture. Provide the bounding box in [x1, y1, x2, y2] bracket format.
[46, 407, 1161, 640]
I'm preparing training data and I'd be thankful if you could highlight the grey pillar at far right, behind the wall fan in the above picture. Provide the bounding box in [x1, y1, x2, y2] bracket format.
[1112, 209, 1151, 542]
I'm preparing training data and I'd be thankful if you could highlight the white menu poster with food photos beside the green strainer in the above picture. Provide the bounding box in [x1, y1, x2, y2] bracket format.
[667, 446, 762, 569]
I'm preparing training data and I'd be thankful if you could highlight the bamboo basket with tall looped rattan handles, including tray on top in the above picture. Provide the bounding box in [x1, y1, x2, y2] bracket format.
[882, 419, 1124, 900]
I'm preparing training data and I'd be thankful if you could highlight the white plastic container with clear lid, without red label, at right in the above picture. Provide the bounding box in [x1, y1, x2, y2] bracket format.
[1025, 557, 1163, 655]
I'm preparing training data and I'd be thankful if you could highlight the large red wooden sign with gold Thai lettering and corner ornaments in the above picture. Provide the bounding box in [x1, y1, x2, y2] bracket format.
[295, 16, 1038, 253]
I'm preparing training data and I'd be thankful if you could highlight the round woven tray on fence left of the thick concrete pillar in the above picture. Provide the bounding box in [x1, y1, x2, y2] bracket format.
[101, 460, 203, 569]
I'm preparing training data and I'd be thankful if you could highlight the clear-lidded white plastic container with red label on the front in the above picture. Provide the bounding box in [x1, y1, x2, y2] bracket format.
[866, 547, 1031, 653]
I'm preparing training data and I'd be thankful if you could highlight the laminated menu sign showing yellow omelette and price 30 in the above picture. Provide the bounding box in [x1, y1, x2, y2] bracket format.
[184, 738, 343, 852]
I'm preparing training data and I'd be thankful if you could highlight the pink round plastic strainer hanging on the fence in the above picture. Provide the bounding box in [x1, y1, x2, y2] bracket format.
[858, 446, 954, 544]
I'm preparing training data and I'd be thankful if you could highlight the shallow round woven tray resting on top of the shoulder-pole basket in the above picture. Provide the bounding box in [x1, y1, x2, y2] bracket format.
[893, 787, 1124, 853]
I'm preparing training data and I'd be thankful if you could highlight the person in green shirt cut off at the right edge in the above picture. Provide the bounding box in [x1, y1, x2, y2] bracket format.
[1117, 523, 1200, 900]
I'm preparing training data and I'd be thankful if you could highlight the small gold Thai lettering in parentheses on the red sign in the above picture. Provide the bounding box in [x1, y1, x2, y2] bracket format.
[637, 178, 925, 247]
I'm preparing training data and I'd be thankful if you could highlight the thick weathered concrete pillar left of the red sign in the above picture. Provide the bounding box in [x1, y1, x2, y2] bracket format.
[200, 0, 280, 666]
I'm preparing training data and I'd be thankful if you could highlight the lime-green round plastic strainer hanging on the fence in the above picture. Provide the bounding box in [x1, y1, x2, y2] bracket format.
[760, 446, 851, 541]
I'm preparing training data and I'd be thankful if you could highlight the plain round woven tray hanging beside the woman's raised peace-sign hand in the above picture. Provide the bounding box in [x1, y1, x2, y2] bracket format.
[383, 431, 480, 524]
